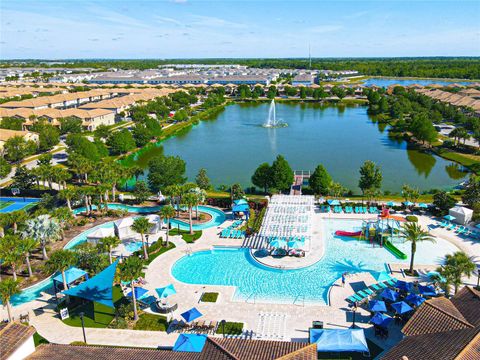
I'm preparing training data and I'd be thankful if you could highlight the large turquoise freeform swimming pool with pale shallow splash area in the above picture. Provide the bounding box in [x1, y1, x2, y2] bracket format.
[171, 220, 458, 304]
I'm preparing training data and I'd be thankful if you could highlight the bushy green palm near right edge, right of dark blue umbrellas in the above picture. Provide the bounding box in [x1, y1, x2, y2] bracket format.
[439, 251, 476, 294]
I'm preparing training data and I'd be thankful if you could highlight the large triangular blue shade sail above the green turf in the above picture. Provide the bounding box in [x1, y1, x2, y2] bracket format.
[63, 260, 118, 308]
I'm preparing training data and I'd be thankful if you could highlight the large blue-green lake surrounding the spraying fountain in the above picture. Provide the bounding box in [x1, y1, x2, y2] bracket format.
[133, 103, 466, 192]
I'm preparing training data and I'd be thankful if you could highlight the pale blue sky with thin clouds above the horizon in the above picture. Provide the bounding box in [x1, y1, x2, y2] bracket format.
[0, 0, 480, 59]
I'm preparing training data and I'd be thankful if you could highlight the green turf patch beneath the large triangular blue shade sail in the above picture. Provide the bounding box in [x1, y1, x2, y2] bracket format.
[63, 286, 128, 328]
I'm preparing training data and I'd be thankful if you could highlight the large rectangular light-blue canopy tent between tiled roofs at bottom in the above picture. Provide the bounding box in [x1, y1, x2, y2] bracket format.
[310, 329, 369, 352]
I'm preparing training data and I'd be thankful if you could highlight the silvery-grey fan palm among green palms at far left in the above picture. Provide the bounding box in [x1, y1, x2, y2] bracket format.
[22, 215, 61, 260]
